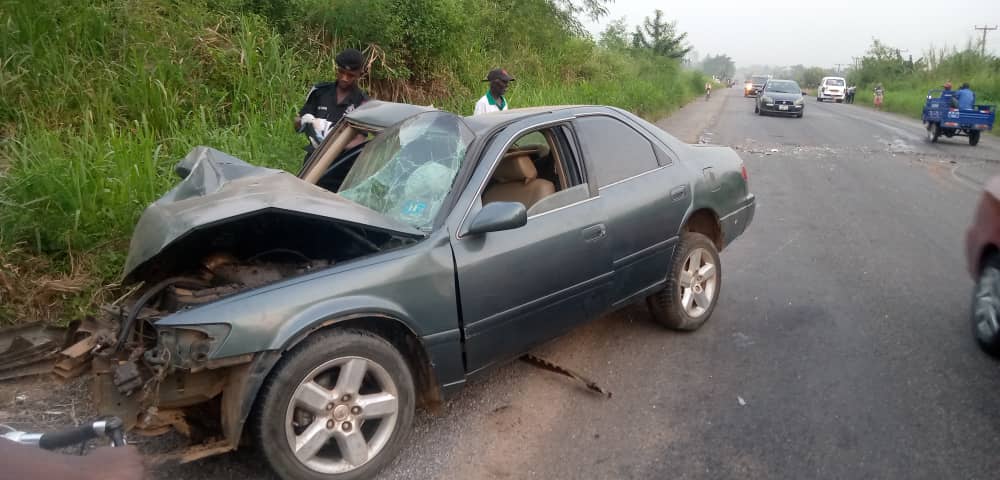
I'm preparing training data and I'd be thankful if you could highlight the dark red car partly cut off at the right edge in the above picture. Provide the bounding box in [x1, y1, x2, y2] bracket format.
[965, 176, 1000, 356]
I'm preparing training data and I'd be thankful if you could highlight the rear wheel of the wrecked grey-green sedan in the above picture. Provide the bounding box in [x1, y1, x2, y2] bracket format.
[646, 232, 722, 331]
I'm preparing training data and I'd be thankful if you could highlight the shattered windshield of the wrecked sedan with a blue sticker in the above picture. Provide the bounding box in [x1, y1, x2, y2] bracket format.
[338, 112, 475, 230]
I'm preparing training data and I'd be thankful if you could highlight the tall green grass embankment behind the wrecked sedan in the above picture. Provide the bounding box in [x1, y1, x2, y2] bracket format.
[0, 0, 704, 325]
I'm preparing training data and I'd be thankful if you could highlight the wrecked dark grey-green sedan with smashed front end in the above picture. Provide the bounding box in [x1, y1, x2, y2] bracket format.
[69, 101, 755, 479]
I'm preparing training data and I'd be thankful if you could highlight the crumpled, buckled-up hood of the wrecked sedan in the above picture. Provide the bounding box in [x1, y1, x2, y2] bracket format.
[124, 146, 425, 278]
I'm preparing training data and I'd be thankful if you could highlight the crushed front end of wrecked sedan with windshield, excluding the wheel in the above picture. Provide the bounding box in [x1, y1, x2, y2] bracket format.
[55, 104, 478, 461]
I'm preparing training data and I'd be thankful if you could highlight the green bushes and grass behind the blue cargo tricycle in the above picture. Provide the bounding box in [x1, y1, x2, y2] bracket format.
[848, 40, 1000, 122]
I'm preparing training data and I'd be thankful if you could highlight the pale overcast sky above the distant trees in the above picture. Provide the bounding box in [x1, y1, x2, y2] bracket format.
[585, 0, 1000, 68]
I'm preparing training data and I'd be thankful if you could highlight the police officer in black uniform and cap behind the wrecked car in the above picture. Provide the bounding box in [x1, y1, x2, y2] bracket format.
[295, 48, 368, 159]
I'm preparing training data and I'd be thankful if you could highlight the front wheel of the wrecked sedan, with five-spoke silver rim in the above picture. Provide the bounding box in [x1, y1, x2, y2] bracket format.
[252, 329, 415, 480]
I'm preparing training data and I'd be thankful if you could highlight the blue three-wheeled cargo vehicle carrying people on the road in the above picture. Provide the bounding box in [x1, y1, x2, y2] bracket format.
[922, 90, 996, 146]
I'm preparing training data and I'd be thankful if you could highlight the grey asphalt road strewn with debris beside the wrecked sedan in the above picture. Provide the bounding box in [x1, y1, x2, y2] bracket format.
[154, 89, 1000, 479]
